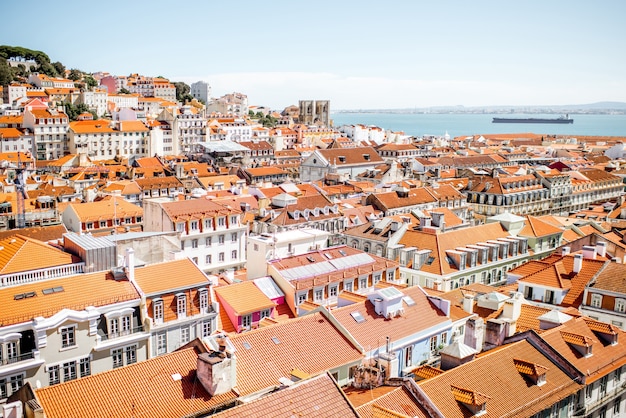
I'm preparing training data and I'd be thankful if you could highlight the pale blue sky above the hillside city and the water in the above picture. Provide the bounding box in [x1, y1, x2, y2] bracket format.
[0, 0, 626, 109]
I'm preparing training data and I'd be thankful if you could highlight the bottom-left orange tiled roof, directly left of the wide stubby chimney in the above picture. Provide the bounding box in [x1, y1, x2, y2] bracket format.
[36, 348, 237, 418]
